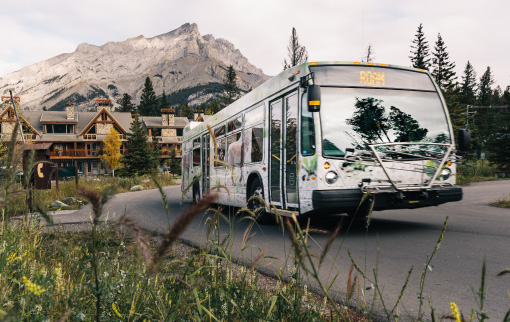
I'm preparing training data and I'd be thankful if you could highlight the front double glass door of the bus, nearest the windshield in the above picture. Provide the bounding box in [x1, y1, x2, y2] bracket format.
[269, 92, 299, 210]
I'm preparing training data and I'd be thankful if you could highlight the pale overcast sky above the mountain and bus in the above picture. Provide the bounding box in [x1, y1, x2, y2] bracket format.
[0, 0, 510, 90]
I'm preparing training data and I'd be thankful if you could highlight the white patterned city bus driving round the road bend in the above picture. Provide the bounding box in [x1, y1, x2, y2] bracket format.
[182, 62, 470, 223]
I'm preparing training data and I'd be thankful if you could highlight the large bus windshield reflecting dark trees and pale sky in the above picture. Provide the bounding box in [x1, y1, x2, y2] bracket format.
[320, 87, 451, 157]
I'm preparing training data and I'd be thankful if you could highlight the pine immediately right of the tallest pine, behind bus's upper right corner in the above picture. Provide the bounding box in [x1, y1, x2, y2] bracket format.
[432, 34, 457, 94]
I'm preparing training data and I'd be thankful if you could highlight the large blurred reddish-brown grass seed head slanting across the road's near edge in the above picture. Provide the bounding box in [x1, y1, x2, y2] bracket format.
[153, 194, 217, 270]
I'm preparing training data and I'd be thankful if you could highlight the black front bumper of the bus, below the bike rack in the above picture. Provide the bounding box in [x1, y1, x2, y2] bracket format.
[312, 186, 462, 213]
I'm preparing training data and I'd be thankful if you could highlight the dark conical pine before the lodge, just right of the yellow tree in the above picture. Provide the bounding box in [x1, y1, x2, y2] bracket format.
[124, 114, 157, 176]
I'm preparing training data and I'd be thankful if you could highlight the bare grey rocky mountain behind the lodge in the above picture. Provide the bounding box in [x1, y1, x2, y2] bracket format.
[0, 24, 269, 110]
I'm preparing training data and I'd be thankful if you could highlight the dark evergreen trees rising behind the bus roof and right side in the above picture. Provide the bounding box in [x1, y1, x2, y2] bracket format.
[283, 24, 510, 166]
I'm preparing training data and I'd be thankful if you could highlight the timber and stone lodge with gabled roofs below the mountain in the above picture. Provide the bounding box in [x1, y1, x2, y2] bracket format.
[0, 96, 193, 175]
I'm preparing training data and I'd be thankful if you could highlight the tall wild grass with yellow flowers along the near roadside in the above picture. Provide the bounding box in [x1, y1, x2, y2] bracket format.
[0, 127, 510, 321]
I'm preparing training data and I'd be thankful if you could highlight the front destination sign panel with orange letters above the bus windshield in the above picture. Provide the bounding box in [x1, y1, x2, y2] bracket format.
[310, 65, 436, 91]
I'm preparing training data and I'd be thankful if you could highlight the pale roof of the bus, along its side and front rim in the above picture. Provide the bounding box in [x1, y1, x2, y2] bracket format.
[184, 61, 429, 140]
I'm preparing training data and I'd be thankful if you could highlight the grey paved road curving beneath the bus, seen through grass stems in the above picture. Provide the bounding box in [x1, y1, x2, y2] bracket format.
[55, 181, 510, 321]
